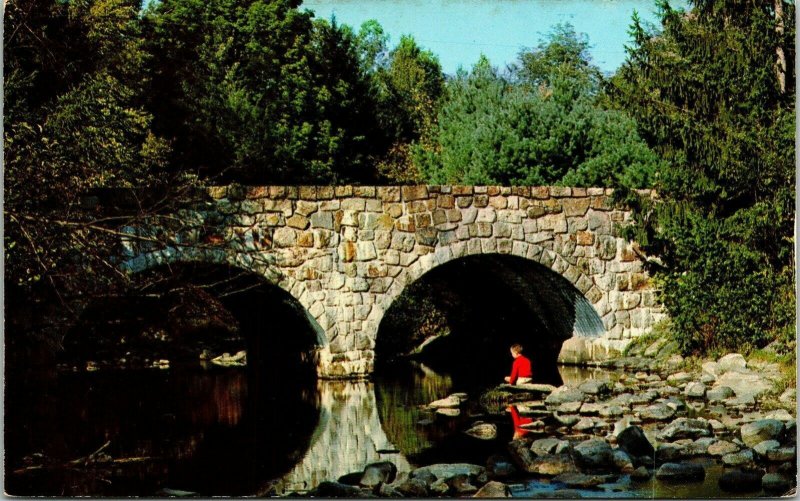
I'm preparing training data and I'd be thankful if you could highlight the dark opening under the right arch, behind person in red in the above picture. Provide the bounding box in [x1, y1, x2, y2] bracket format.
[375, 254, 605, 384]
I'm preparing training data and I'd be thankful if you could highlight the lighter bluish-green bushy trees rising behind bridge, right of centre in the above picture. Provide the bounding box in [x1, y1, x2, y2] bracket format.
[417, 26, 659, 188]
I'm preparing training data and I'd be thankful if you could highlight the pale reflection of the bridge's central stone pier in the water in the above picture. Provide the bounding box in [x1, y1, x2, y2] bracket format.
[274, 381, 411, 494]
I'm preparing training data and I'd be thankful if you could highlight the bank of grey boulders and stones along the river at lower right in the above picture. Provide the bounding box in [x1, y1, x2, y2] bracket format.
[298, 353, 797, 498]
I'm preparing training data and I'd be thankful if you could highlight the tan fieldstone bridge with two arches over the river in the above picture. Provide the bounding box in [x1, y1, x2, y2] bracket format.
[122, 186, 664, 377]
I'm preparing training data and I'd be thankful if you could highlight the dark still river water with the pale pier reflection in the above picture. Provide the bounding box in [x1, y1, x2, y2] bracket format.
[5, 364, 764, 498]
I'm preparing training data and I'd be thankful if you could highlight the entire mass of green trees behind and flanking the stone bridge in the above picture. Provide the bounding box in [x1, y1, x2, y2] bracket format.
[4, 0, 795, 360]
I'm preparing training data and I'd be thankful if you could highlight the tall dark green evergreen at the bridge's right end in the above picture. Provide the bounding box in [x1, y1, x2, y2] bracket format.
[609, 0, 795, 352]
